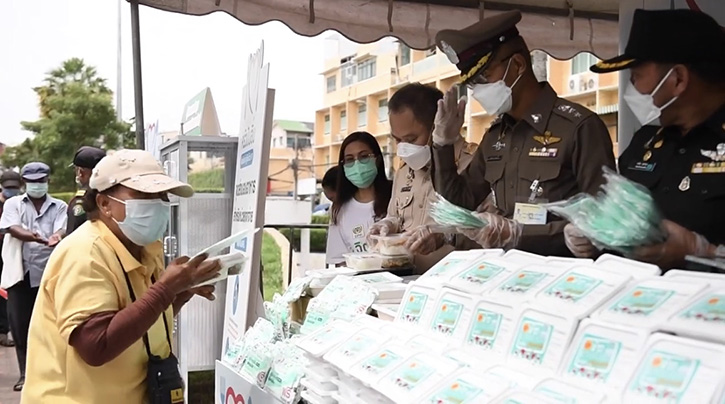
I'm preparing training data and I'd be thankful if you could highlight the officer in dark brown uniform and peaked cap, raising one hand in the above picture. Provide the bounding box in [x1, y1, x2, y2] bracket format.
[433, 11, 615, 255]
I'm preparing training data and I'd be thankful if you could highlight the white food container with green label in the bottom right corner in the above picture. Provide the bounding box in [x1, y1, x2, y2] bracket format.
[621, 334, 725, 404]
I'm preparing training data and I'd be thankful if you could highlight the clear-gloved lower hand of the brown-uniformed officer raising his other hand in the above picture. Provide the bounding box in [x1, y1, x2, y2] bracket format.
[457, 212, 524, 249]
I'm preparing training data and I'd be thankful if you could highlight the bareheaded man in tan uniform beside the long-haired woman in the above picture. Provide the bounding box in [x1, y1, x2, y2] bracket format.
[370, 83, 477, 273]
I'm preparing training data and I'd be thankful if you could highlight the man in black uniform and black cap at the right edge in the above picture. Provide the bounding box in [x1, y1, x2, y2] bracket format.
[565, 10, 725, 269]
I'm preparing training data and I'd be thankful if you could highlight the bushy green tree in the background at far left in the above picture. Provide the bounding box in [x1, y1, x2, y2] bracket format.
[2, 58, 135, 192]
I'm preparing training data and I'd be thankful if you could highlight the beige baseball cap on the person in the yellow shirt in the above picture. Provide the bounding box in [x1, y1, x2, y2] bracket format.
[89, 149, 194, 198]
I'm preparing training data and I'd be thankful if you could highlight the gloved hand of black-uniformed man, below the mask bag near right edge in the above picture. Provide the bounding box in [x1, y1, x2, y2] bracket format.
[632, 220, 714, 269]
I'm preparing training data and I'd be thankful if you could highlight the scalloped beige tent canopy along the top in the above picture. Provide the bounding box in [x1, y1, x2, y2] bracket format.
[138, 0, 619, 59]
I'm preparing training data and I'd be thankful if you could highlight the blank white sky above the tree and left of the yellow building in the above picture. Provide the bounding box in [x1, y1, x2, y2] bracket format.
[0, 0, 325, 145]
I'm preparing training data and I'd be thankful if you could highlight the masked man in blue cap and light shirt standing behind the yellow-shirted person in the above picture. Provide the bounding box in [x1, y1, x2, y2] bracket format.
[0, 162, 68, 391]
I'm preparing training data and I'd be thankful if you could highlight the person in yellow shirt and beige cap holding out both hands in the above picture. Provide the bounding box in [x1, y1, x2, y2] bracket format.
[21, 150, 220, 404]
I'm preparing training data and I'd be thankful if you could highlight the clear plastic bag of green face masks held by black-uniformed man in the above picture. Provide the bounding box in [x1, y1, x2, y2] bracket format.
[544, 167, 665, 254]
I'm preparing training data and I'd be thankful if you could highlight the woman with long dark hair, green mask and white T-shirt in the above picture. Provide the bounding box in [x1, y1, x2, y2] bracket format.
[327, 132, 392, 264]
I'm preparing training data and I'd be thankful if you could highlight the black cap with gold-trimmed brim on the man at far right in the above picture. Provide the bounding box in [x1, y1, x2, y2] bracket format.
[591, 9, 725, 73]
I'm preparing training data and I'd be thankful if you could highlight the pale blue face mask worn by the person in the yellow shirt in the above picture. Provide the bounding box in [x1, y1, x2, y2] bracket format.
[109, 196, 170, 247]
